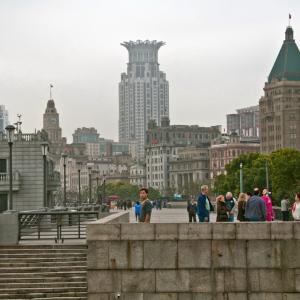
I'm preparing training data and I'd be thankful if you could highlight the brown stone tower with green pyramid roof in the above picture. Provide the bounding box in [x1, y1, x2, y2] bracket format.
[259, 26, 300, 153]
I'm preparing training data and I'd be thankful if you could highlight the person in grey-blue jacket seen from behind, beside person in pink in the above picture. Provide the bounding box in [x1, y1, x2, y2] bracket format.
[245, 188, 267, 222]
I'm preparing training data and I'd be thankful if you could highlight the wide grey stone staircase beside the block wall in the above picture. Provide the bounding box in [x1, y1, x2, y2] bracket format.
[0, 245, 87, 300]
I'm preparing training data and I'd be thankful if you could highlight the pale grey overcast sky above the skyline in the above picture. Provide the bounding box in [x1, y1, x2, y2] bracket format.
[0, 0, 300, 142]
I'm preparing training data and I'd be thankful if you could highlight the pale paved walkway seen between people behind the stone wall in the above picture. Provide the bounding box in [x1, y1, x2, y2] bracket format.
[129, 208, 216, 223]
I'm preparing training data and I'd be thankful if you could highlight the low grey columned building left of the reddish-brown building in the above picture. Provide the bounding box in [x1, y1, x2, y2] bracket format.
[169, 146, 209, 194]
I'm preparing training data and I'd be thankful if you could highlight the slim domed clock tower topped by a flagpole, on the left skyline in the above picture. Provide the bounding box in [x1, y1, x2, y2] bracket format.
[43, 97, 62, 143]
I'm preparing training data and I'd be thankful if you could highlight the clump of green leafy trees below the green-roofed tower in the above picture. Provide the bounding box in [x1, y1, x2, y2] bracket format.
[214, 149, 300, 205]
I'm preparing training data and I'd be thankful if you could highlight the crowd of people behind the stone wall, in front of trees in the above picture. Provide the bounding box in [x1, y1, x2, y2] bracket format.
[187, 185, 300, 222]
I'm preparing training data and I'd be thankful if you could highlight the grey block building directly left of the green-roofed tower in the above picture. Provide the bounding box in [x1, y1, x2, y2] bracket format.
[227, 105, 259, 137]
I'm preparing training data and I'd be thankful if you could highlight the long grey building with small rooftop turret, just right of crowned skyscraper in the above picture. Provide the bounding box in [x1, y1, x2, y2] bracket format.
[145, 117, 221, 194]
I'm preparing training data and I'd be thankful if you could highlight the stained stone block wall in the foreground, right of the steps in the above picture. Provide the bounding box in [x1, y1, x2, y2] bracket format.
[87, 222, 300, 300]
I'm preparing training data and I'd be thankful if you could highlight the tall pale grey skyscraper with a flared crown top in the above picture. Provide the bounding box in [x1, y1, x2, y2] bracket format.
[119, 40, 169, 160]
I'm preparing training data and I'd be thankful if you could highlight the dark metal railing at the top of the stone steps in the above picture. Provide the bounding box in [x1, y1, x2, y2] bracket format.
[19, 211, 99, 243]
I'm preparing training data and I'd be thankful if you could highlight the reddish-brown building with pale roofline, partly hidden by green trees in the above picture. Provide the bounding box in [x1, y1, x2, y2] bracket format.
[209, 134, 260, 179]
